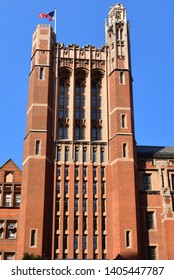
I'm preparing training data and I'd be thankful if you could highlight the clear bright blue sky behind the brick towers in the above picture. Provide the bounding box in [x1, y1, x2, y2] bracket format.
[0, 0, 174, 168]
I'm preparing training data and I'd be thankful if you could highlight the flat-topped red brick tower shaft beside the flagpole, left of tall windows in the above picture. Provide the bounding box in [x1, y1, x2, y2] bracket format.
[17, 25, 55, 258]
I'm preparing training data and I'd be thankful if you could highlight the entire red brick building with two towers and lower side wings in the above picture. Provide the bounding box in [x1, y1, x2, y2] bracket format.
[0, 3, 174, 259]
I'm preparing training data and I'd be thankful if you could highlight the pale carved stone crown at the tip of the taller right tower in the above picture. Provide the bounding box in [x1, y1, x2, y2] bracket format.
[108, 3, 126, 26]
